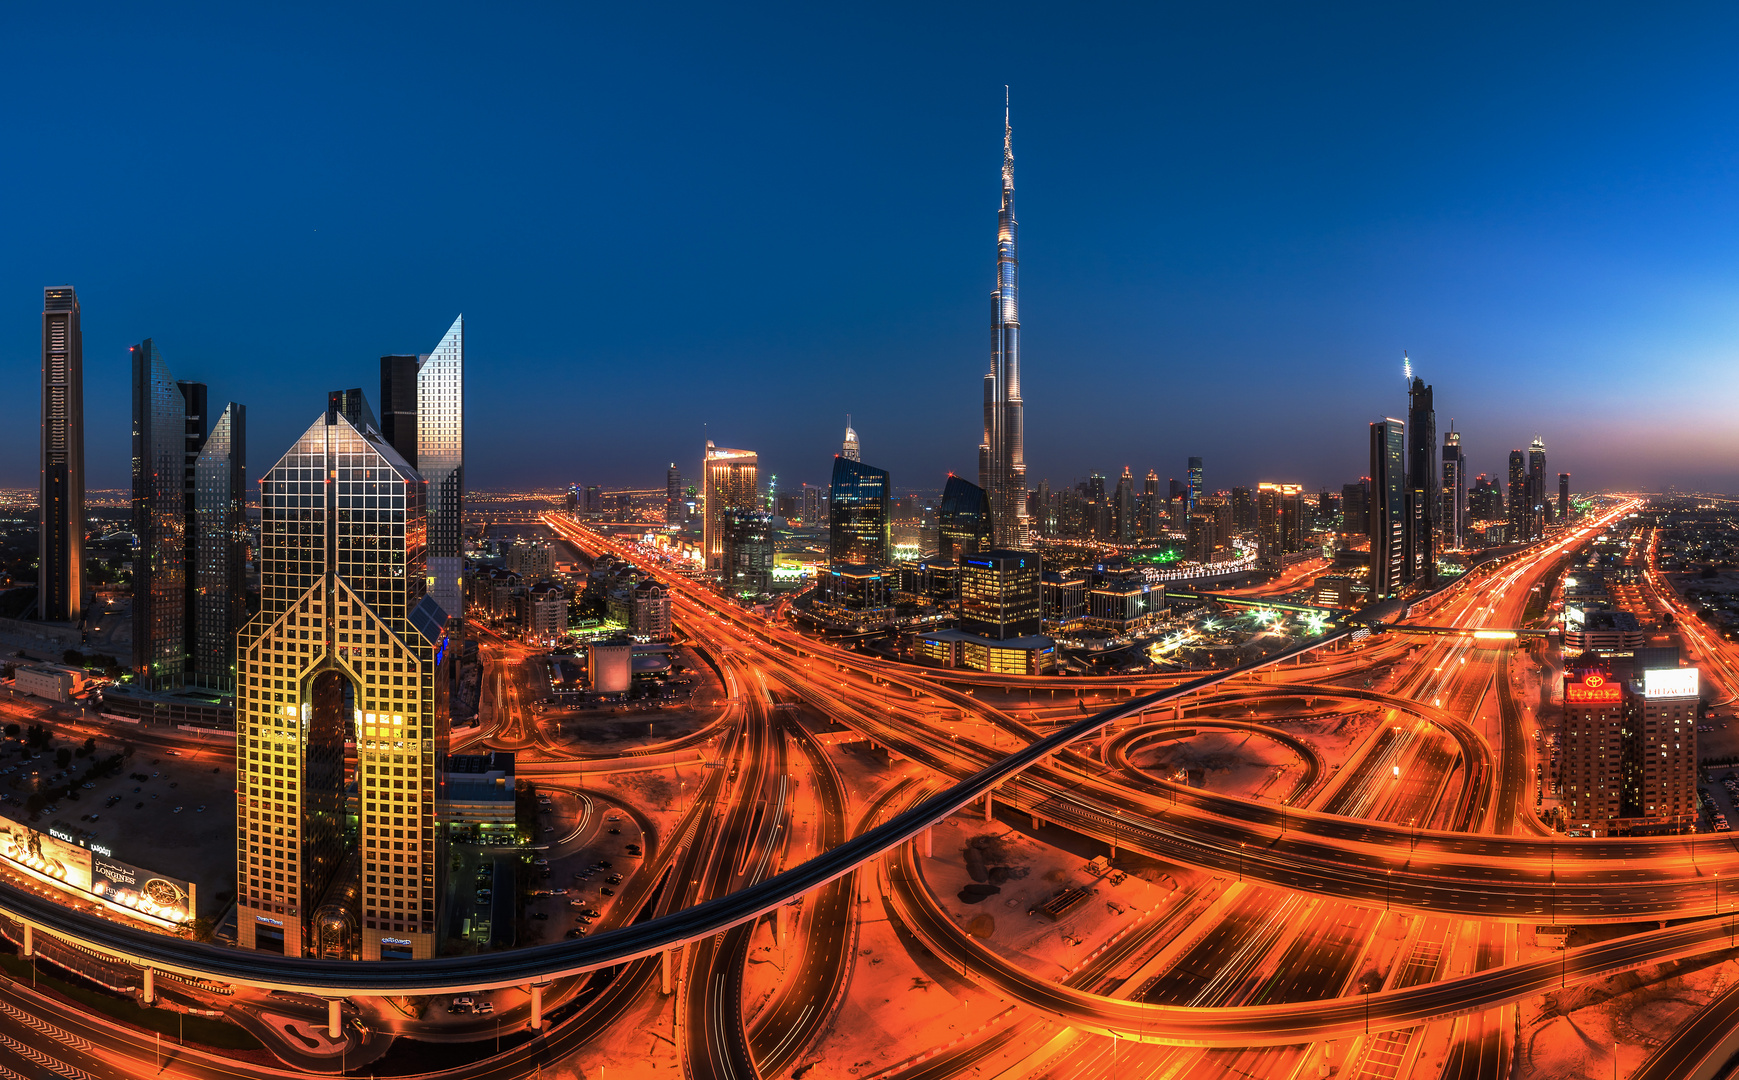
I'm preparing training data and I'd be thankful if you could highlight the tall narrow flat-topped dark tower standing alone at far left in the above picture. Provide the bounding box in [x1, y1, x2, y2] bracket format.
[37, 285, 85, 623]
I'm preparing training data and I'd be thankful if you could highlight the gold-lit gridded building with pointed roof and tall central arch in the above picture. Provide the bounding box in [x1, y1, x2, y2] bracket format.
[237, 393, 452, 960]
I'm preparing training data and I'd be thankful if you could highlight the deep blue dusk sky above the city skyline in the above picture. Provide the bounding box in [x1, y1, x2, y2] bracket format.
[0, 3, 1739, 490]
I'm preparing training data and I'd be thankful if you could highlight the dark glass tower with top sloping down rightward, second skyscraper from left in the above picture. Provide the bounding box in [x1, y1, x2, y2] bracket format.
[132, 337, 188, 690]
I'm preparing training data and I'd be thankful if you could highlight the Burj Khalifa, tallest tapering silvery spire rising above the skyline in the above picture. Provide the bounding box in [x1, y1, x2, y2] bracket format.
[979, 94, 1028, 548]
